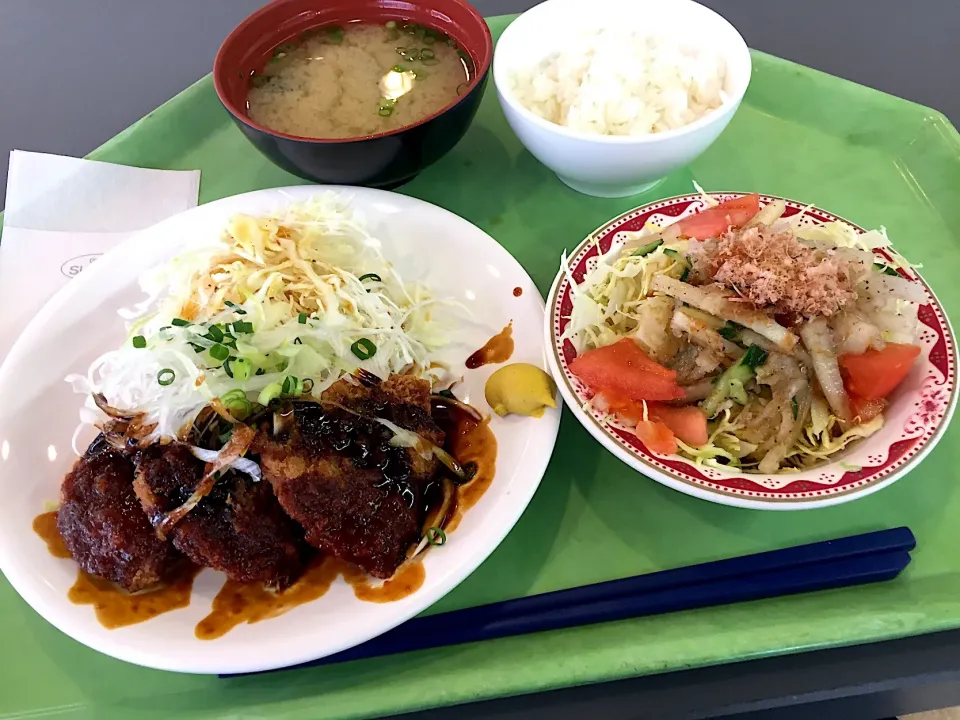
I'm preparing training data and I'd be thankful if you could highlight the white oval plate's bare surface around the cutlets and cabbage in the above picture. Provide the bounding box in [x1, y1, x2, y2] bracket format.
[0, 186, 560, 673]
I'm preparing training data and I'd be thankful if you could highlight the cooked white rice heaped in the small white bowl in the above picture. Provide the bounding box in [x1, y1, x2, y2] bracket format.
[512, 30, 726, 135]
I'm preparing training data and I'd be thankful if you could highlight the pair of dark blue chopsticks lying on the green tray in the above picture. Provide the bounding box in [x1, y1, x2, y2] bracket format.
[223, 527, 916, 677]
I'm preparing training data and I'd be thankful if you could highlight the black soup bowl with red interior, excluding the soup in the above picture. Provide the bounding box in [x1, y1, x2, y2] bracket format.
[213, 0, 493, 189]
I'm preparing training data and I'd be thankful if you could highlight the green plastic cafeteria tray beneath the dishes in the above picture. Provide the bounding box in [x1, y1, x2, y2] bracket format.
[0, 12, 960, 720]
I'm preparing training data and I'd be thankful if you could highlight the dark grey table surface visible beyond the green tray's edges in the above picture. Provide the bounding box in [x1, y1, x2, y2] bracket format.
[0, 0, 960, 720]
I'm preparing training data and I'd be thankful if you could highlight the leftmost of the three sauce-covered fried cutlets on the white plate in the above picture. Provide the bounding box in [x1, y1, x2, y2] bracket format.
[57, 436, 185, 592]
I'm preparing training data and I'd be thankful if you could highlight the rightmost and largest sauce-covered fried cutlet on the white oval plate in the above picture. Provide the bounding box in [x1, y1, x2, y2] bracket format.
[255, 375, 443, 578]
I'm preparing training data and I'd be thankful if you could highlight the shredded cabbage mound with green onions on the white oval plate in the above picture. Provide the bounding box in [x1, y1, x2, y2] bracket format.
[67, 193, 459, 441]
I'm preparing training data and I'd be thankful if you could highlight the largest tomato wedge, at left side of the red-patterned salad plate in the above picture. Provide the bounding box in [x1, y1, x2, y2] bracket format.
[570, 338, 685, 402]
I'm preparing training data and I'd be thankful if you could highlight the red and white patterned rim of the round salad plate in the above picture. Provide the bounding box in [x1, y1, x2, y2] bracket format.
[545, 192, 957, 510]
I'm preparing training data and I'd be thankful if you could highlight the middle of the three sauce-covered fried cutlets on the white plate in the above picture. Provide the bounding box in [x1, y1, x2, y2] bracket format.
[133, 444, 303, 588]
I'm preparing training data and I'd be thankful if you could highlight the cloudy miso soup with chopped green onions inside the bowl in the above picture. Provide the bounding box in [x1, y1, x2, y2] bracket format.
[247, 21, 473, 139]
